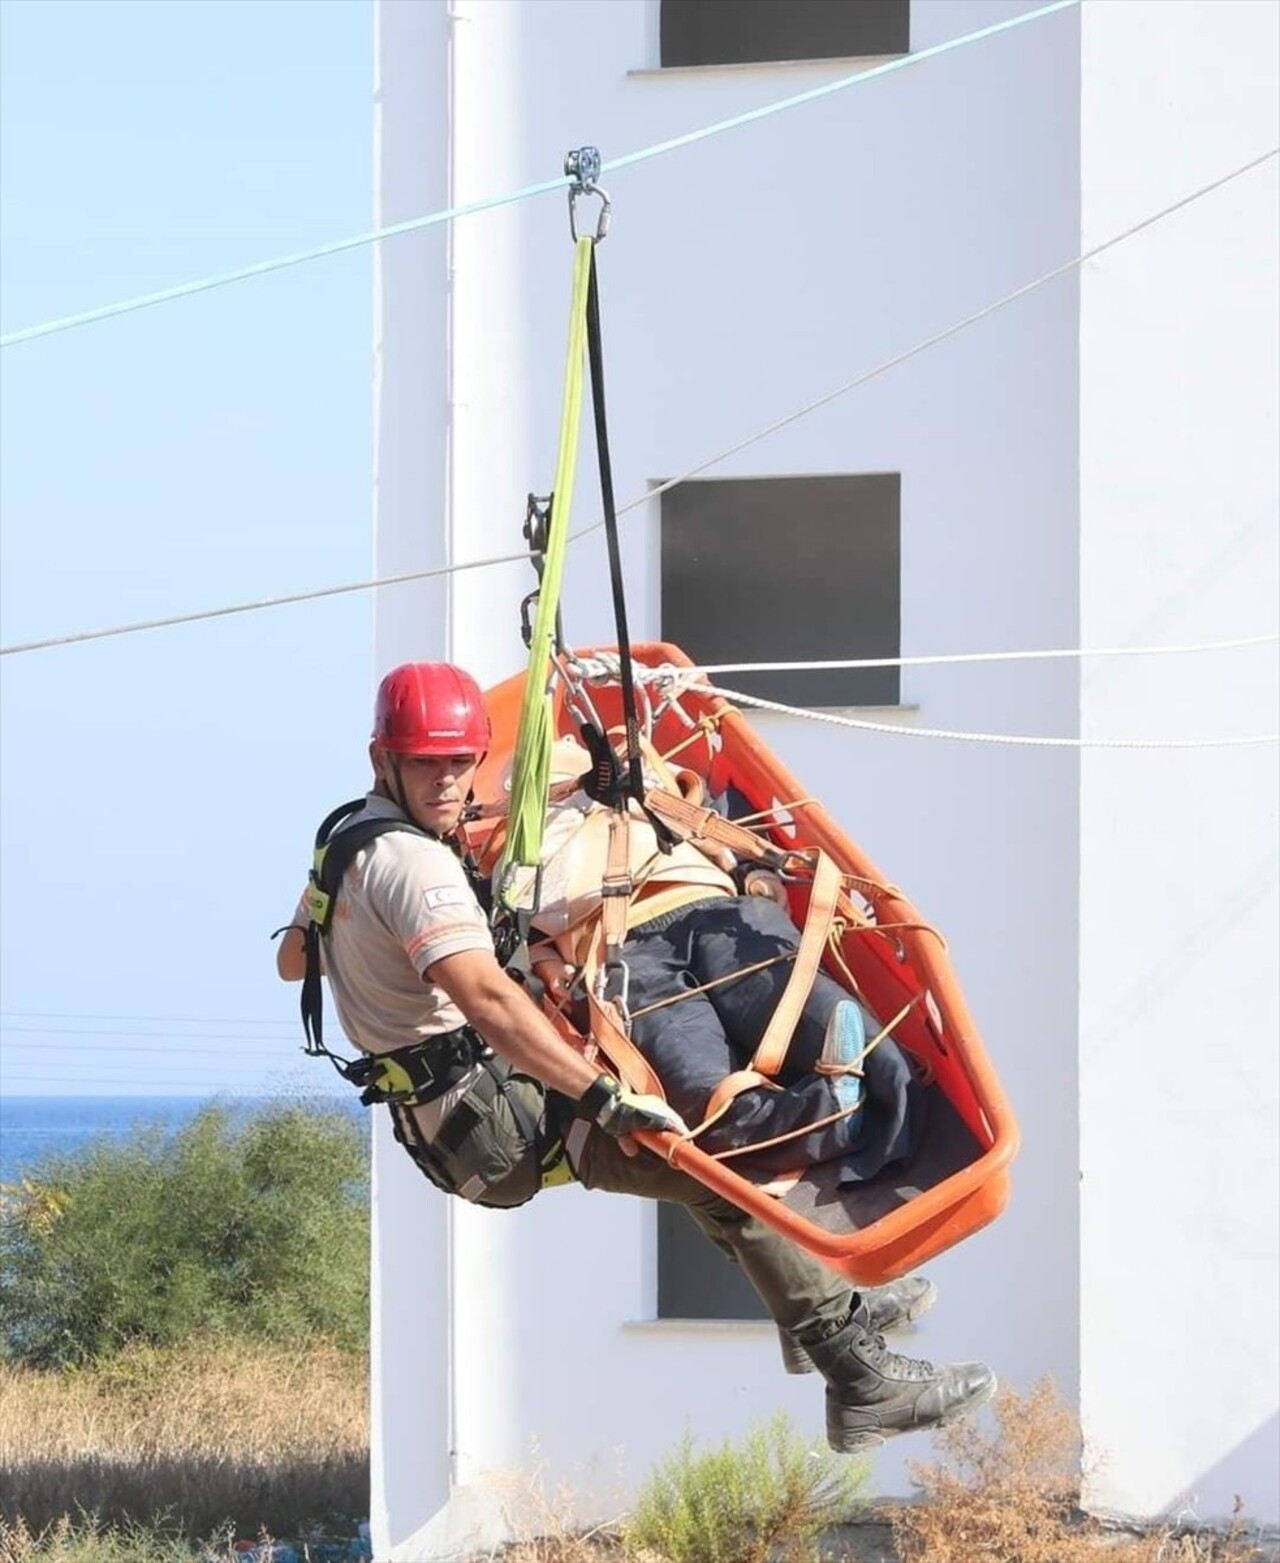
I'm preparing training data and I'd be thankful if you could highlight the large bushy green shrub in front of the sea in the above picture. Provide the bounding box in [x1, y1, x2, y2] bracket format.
[0, 1105, 369, 1366]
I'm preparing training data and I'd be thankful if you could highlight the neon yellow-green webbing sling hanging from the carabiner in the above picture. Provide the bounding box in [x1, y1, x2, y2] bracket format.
[497, 239, 594, 911]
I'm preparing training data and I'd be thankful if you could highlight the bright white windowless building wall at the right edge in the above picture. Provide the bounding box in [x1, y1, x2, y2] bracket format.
[1080, 0, 1280, 1521]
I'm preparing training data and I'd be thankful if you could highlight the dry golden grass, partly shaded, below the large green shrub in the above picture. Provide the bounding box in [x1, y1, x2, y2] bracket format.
[0, 1343, 369, 1535]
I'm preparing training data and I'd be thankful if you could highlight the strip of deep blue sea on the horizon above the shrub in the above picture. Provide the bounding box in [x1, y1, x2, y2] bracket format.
[0, 1093, 367, 1183]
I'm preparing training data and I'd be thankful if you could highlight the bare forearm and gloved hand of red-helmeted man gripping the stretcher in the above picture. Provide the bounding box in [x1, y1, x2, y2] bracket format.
[424, 950, 686, 1133]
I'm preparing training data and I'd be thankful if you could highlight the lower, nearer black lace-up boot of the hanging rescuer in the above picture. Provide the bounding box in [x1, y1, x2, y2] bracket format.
[805, 1304, 996, 1454]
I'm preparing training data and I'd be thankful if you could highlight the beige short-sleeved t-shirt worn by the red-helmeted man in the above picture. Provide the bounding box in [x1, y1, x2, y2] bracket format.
[295, 792, 494, 1053]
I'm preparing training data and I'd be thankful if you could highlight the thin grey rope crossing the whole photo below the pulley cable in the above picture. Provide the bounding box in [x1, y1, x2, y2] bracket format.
[0, 146, 1280, 656]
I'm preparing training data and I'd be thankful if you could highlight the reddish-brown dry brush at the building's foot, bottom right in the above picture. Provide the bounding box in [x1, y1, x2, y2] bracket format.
[892, 1380, 1264, 1563]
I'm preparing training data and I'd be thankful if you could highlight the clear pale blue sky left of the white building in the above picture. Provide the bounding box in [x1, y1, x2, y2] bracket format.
[0, 0, 372, 1094]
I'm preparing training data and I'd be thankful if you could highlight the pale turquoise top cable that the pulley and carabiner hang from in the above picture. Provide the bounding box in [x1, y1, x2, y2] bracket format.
[0, 0, 1080, 347]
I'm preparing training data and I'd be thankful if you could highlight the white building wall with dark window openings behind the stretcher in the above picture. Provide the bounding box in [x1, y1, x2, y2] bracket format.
[374, 0, 1080, 1557]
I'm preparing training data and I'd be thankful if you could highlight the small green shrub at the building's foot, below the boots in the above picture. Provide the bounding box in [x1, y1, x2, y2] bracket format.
[624, 1415, 869, 1563]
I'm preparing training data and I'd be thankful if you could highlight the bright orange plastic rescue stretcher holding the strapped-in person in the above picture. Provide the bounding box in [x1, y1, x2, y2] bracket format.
[469, 642, 1019, 1285]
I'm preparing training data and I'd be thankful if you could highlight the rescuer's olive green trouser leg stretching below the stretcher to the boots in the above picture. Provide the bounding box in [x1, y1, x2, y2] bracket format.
[577, 1128, 853, 1341]
